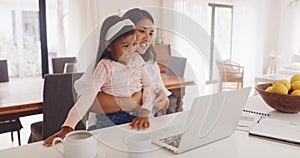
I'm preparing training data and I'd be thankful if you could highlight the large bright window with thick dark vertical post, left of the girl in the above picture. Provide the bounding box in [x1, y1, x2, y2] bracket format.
[0, 0, 68, 77]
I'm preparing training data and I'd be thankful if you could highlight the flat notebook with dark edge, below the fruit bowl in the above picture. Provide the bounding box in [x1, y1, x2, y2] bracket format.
[249, 118, 300, 144]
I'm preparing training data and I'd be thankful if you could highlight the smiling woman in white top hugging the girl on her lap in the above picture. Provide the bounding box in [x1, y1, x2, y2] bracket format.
[86, 8, 171, 130]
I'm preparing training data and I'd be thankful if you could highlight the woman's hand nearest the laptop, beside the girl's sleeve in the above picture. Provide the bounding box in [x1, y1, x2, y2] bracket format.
[153, 88, 169, 112]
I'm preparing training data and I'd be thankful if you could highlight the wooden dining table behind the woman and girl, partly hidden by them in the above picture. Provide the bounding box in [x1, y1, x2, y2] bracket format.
[0, 74, 195, 121]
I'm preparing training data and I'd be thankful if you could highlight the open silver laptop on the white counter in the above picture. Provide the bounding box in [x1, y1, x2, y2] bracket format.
[152, 87, 251, 153]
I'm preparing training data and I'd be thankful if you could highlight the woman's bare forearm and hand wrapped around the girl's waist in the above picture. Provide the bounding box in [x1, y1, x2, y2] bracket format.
[89, 91, 143, 114]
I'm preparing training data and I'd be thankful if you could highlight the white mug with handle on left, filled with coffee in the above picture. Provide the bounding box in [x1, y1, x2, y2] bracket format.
[52, 130, 97, 158]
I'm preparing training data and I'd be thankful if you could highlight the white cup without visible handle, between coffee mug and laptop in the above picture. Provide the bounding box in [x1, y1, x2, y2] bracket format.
[127, 133, 151, 158]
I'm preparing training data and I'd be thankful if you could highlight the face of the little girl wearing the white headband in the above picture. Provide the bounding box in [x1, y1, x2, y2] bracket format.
[107, 34, 136, 63]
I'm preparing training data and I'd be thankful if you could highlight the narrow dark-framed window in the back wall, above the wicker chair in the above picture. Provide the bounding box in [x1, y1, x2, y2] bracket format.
[208, 3, 233, 82]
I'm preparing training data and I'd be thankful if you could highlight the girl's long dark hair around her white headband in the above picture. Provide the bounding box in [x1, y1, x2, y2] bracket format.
[95, 15, 134, 67]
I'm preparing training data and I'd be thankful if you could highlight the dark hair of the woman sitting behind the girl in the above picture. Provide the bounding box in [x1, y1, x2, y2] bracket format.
[123, 8, 157, 61]
